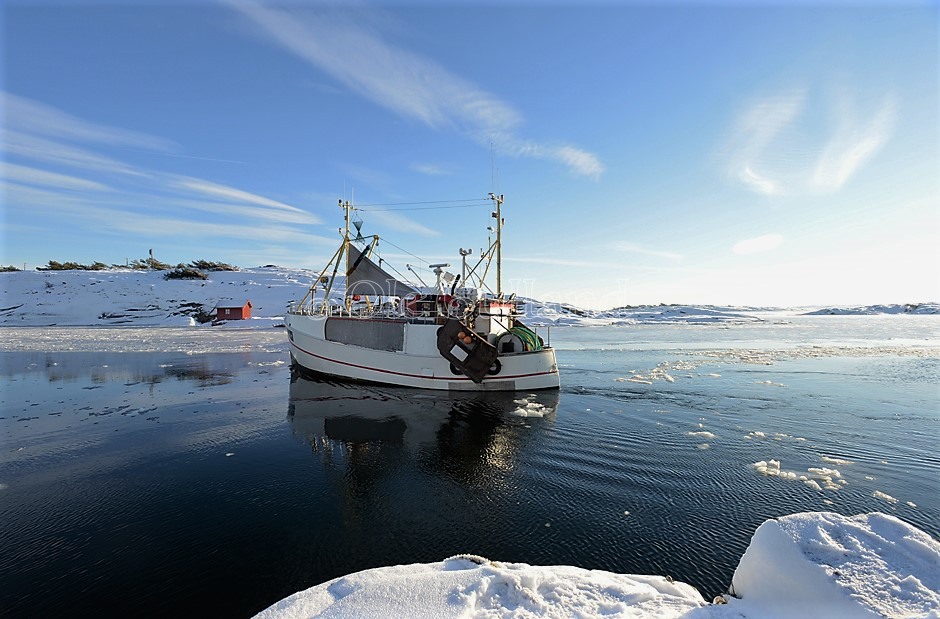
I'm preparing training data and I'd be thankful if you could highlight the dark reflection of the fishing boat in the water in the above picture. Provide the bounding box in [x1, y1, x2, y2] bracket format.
[288, 372, 559, 486]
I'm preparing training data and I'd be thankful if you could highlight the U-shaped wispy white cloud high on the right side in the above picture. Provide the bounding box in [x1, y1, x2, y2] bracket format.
[723, 89, 897, 196]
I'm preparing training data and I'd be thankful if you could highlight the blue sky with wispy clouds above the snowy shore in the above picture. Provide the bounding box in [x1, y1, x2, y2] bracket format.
[0, 0, 940, 309]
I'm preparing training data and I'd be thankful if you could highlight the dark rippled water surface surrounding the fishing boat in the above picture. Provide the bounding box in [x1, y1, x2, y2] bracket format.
[0, 317, 940, 617]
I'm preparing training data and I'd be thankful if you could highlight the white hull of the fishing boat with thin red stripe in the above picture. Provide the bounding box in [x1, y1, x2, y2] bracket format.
[285, 314, 560, 391]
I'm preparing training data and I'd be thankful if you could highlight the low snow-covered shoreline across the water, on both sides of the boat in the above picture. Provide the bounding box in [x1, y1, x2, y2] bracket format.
[0, 266, 940, 327]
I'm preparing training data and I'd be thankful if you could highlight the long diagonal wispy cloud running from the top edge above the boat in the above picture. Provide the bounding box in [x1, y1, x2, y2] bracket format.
[228, 0, 604, 178]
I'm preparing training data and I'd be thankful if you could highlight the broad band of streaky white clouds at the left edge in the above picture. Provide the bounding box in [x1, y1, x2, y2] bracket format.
[0, 93, 320, 242]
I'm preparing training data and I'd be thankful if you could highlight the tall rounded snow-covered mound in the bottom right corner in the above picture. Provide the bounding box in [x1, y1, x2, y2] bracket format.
[729, 512, 940, 619]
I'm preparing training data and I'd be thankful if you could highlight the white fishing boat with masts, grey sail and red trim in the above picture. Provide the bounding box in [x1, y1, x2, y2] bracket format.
[284, 193, 559, 391]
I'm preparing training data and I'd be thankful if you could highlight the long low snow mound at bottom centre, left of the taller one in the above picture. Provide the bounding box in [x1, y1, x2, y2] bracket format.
[257, 558, 706, 619]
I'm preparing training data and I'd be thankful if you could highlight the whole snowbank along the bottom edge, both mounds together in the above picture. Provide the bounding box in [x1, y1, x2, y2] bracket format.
[257, 512, 940, 619]
